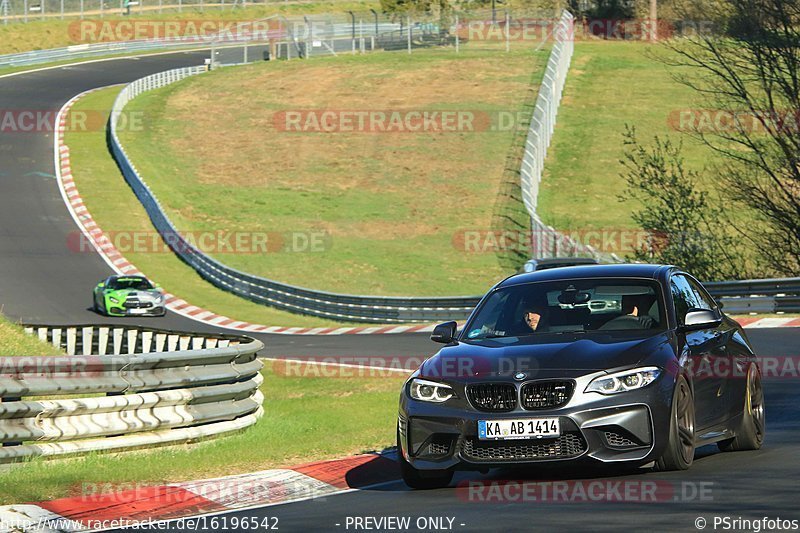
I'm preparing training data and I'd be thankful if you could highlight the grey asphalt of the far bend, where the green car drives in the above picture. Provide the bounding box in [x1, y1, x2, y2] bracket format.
[0, 51, 431, 357]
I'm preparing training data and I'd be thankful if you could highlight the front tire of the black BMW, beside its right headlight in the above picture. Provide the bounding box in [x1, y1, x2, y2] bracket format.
[655, 376, 695, 471]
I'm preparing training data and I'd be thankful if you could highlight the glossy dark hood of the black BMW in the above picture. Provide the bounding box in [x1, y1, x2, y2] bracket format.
[420, 332, 671, 380]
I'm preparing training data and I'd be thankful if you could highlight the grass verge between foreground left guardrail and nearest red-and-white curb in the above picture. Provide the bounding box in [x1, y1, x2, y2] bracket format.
[0, 362, 404, 504]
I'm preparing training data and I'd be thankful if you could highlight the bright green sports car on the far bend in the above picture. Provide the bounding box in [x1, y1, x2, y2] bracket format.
[92, 276, 167, 316]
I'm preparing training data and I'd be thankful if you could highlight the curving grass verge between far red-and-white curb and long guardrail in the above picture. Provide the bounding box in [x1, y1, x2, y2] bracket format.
[65, 87, 368, 327]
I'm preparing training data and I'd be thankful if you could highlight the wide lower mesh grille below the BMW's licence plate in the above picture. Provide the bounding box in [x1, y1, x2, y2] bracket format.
[461, 432, 586, 463]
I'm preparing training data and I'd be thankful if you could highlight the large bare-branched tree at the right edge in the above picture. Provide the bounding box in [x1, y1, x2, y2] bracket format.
[662, 0, 800, 276]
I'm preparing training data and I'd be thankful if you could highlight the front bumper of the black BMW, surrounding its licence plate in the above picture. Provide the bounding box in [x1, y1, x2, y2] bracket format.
[398, 375, 674, 470]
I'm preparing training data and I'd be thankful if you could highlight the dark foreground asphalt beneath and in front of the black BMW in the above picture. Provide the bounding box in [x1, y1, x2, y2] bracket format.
[119, 328, 800, 532]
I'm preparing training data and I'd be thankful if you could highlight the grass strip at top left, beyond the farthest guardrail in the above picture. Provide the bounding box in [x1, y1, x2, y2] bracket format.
[0, 0, 380, 55]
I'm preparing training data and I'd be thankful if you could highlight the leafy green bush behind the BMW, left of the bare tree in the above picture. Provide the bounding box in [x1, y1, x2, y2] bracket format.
[619, 128, 749, 280]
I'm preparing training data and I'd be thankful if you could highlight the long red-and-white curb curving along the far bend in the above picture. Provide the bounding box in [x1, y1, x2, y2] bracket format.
[54, 87, 434, 335]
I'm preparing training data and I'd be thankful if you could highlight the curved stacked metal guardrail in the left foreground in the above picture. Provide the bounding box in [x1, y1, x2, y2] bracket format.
[0, 325, 264, 463]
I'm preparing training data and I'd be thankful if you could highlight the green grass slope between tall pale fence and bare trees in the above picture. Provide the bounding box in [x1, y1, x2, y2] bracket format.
[539, 41, 711, 234]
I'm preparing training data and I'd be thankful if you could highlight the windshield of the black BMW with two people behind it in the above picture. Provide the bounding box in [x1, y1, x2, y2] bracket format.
[465, 279, 666, 340]
